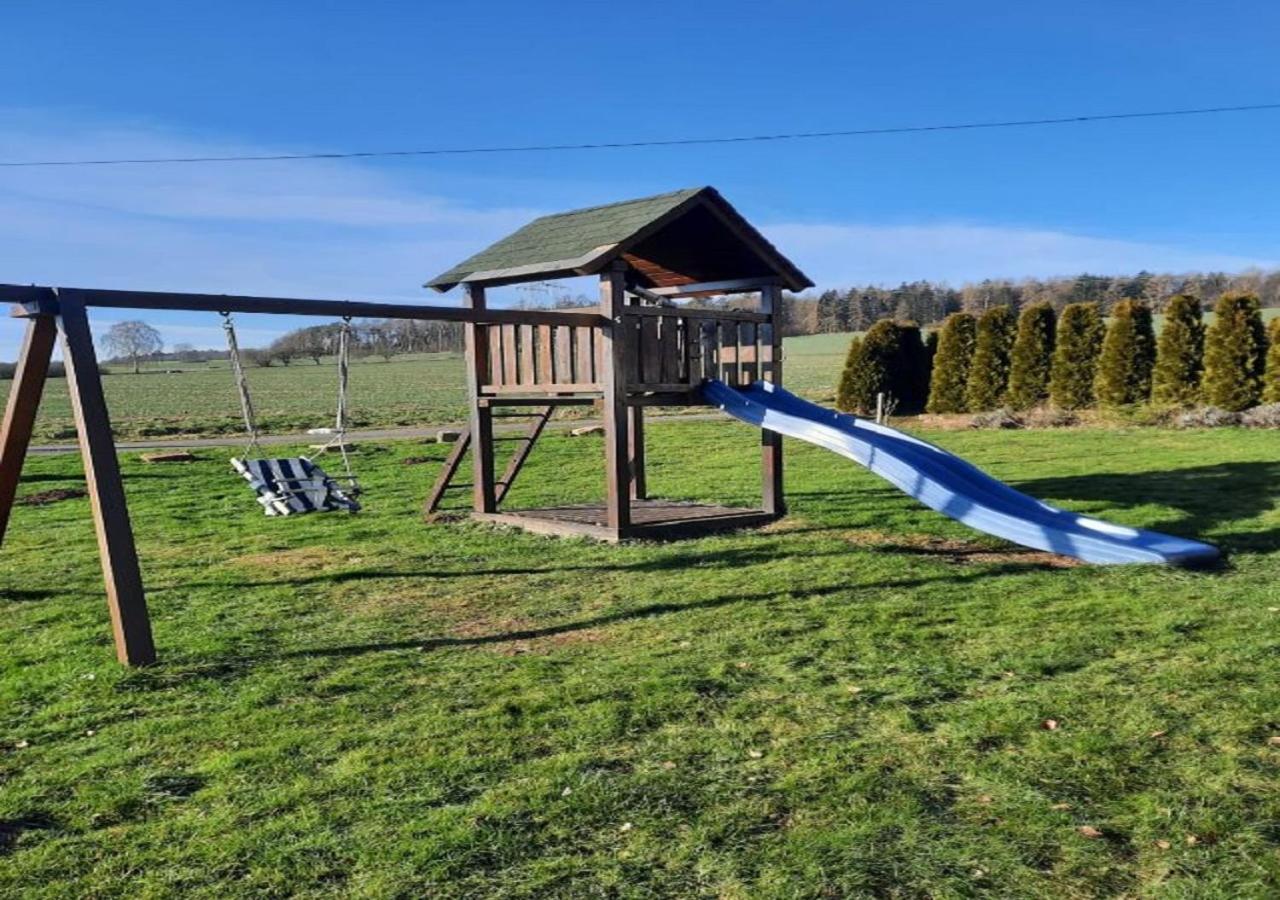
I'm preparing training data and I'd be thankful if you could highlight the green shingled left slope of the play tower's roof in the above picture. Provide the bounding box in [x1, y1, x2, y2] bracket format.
[426, 187, 712, 291]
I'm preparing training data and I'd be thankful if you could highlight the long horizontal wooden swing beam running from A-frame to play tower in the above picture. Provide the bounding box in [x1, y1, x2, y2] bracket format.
[0, 284, 605, 326]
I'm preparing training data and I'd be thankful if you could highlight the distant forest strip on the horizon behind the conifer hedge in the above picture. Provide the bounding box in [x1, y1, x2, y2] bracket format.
[786, 269, 1280, 334]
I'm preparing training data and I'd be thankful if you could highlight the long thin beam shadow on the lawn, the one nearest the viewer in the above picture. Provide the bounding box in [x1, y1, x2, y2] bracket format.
[272, 563, 1048, 662]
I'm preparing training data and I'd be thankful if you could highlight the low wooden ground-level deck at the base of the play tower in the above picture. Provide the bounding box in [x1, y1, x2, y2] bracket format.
[472, 499, 777, 543]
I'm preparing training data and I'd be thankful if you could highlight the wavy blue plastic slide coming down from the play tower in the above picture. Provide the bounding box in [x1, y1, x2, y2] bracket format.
[703, 380, 1219, 566]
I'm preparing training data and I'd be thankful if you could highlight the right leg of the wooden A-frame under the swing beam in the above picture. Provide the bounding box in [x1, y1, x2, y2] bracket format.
[58, 301, 156, 666]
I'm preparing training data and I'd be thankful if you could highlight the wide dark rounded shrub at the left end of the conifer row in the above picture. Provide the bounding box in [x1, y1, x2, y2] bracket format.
[836, 319, 927, 415]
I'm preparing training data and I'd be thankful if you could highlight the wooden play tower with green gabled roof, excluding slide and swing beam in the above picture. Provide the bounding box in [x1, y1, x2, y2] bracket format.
[428, 187, 812, 540]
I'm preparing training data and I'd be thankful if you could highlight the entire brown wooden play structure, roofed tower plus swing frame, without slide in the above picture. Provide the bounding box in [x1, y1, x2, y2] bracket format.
[0, 187, 812, 664]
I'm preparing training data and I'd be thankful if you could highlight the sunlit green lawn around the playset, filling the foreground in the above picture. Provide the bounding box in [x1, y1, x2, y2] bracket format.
[0, 422, 1280, 897]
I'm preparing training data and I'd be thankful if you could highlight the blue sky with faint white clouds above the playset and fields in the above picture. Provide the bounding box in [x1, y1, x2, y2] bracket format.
[0, 0, 1280, 358]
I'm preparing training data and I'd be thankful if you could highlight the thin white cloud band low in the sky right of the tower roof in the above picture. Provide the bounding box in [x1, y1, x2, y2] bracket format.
[763, 223, 1276, 285]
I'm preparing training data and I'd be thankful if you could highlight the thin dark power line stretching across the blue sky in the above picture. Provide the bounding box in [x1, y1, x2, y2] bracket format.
[0, 102, 1280, 169]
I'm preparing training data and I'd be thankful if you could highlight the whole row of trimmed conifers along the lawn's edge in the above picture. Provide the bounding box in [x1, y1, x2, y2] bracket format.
[836, 293, 1280, 414]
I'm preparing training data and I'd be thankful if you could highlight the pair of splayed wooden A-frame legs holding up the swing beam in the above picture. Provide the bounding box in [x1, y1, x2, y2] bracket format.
[0, 301, 156, 666]
